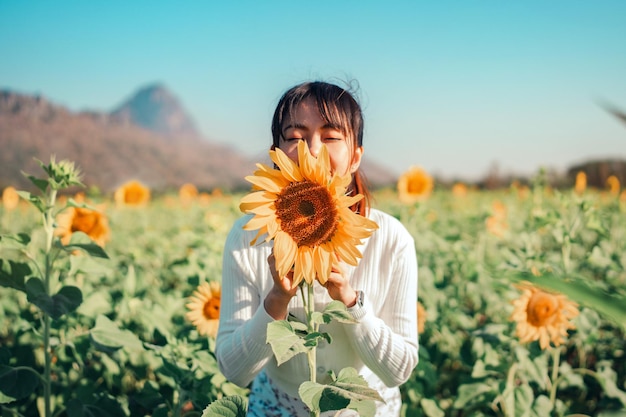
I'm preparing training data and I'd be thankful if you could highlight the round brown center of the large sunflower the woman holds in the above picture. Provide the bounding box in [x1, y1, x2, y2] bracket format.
[275, 181, 338, 246]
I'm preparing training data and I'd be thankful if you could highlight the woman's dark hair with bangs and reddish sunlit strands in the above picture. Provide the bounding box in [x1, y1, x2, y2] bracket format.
[272, 81, 371, 216]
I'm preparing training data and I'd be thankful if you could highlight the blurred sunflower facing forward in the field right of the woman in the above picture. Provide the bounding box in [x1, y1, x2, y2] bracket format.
[510, 282, 578, 349]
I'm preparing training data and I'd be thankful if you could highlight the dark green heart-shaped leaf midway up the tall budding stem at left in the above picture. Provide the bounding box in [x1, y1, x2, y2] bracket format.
[26, 277, 83, 320]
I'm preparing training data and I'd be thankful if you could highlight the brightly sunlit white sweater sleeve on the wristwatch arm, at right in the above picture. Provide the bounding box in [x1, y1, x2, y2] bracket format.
[346, 211, 418, 387]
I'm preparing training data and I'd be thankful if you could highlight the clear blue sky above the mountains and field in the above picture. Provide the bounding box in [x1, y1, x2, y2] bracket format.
[0, 0, 626, 180]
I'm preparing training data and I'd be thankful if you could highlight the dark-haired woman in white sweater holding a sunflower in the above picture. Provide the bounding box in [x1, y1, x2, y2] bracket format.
[216, 82, 418, 417]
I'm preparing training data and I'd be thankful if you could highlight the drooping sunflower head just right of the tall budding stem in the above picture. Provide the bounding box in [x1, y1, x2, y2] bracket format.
[55, 207, 111, 247]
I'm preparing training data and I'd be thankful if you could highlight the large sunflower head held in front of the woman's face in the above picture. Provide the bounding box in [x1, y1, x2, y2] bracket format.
[240, 141, 378, 285]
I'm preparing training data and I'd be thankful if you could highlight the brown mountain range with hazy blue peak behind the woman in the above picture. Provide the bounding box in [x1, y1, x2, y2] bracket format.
[0, 84, 395, 192]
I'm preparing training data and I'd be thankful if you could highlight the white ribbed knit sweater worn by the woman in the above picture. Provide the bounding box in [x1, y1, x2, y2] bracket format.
[215, 209, 418, 397]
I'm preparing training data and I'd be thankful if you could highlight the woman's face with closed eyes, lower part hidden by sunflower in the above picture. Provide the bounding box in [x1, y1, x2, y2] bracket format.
[278, 99, 363, 175]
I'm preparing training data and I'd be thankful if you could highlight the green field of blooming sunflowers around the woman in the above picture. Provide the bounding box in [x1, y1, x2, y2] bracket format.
[0, 162, 626, 417]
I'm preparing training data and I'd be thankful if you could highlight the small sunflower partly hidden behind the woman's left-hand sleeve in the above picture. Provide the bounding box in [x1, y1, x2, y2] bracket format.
[185, 281, 222, 338]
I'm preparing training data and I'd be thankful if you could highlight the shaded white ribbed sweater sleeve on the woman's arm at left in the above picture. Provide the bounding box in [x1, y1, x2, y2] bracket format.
[215, 217, 273, 387]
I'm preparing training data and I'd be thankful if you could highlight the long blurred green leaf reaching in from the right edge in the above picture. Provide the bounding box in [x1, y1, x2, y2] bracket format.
[510, 272, 626, 330]
